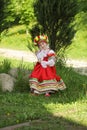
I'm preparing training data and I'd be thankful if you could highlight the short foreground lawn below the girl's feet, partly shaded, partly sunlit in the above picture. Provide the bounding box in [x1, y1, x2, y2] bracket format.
[0, 92, 87, 130]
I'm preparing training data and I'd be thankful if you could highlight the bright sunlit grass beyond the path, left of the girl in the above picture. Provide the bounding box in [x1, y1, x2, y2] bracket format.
[0, 25, 28, 51]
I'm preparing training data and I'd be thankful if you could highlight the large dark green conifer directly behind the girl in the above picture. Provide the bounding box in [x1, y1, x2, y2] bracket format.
[34, 0, 77, 51]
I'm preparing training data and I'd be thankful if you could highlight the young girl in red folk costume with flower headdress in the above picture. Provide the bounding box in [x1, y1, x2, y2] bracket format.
[29, 35, 66, 96]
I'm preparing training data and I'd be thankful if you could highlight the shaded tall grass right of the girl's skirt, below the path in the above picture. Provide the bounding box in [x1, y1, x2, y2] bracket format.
[56, 61, 87, 102]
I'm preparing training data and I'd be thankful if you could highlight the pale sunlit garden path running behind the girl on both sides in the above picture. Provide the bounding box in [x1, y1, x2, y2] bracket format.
[0, 48, 87, 75]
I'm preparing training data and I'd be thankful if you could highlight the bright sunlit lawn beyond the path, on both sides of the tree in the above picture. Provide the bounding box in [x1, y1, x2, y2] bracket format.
[0, 25, 87, 60]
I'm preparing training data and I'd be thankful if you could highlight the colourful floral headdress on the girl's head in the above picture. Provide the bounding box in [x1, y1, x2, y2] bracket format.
[34, 34, 48, 45]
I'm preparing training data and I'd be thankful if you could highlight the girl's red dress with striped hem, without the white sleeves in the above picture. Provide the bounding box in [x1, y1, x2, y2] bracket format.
[29, 51, 66, 94]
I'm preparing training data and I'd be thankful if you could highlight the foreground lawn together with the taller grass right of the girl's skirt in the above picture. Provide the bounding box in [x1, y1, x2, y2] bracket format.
[0, 58, 87, 130]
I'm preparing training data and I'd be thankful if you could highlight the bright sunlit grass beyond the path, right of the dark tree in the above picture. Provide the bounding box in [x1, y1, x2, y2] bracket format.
[66, 29, 87, 61]
